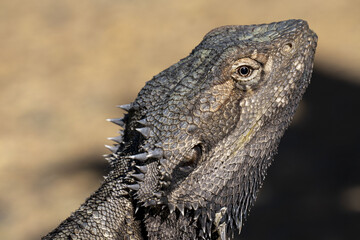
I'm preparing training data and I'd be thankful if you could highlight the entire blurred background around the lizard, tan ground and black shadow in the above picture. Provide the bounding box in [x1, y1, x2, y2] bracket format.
[0, 0, 360, 240]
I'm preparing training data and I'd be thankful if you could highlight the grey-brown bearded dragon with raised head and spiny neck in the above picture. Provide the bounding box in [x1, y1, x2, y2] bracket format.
[44, 20, 317, 239]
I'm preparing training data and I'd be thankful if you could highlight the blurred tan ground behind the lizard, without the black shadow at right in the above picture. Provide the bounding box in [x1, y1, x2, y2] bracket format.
[0, 0, 360, 240]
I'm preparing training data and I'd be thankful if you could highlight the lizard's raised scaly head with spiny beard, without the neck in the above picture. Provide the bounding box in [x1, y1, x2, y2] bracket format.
[110, 20, 317, 238]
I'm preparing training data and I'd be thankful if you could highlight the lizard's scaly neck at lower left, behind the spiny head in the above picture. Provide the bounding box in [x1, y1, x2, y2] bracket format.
[43, 173, 142, 240]
